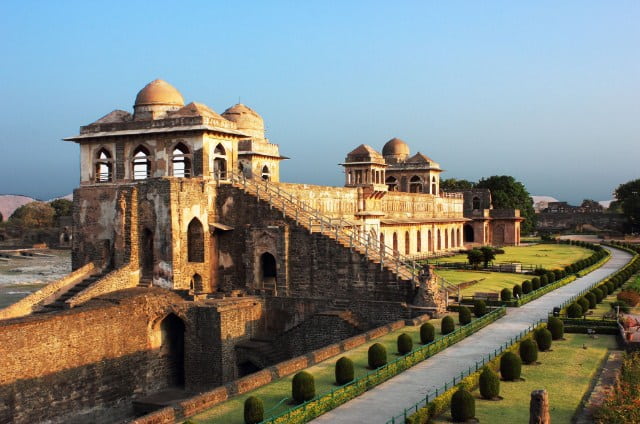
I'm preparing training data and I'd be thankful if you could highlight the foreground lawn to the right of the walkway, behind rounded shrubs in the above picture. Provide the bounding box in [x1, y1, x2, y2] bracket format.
[434, 334, 617, 423]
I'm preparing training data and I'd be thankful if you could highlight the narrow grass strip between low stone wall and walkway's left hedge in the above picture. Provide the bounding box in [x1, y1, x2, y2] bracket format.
[192, 314, 468, 424]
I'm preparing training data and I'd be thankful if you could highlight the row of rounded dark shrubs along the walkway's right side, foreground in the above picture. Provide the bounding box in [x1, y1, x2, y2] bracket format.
[407, 317, 564, 424]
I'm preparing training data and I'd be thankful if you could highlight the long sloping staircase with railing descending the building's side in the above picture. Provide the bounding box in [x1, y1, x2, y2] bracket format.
[222, 171, 418, 284]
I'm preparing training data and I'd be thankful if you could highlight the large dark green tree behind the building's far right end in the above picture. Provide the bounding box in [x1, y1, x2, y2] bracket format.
[476, 175, 536, 234]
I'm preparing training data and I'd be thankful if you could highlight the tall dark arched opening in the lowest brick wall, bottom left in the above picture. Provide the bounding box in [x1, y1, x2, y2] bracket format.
[160, 314, 185, 388]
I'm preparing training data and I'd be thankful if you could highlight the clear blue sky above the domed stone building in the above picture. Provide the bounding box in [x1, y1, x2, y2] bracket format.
[0, 0, 640, 204]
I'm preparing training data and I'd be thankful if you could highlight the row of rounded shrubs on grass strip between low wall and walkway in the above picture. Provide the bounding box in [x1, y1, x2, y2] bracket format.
[244, 316, 486, 424]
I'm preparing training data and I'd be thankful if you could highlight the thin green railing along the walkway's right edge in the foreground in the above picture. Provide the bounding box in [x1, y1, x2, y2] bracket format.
[386, 318, 546, 424]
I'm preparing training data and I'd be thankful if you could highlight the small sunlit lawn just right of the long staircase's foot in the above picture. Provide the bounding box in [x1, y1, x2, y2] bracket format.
[436, 268, 533, 296]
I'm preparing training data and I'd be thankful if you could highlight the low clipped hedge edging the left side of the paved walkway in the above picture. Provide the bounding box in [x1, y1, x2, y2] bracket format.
[261, 307, 506, 424]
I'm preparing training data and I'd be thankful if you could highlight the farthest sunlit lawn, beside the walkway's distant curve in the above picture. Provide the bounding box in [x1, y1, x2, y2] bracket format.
[436, 244, 593, 269]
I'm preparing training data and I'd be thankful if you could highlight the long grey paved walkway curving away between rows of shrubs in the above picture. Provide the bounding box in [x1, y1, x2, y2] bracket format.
[312, 249, 631, 424]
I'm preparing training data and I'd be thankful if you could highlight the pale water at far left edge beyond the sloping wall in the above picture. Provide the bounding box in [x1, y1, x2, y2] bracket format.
[0, 249, 71, 308]
